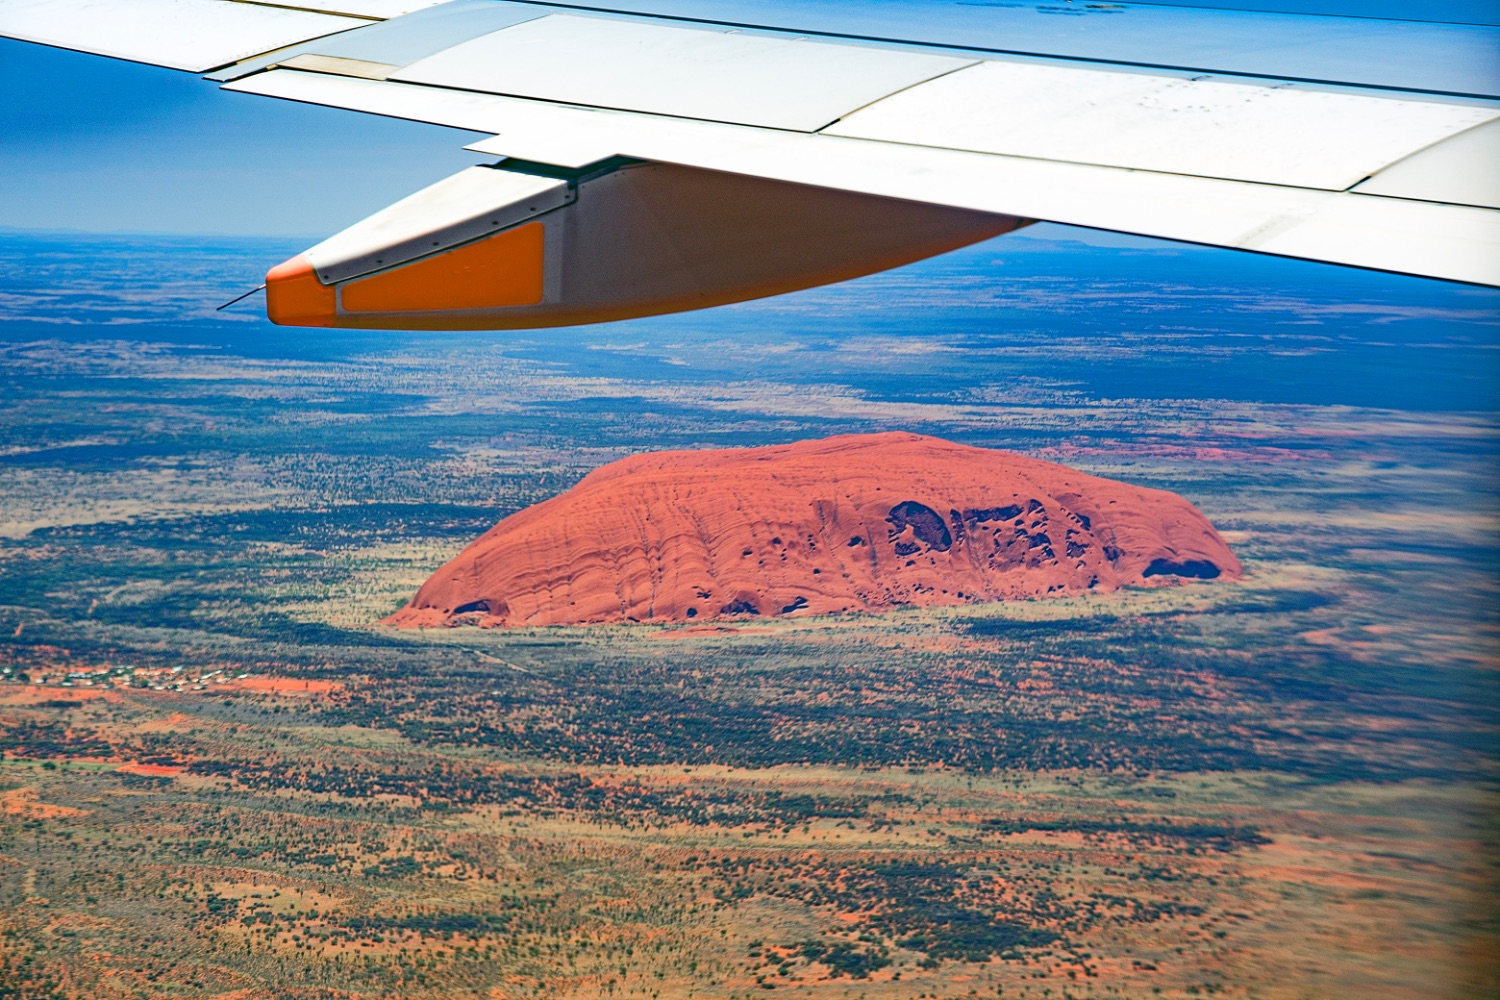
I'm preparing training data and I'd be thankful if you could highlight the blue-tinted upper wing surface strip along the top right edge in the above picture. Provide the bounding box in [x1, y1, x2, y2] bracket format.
[519, 0, 1500, 96]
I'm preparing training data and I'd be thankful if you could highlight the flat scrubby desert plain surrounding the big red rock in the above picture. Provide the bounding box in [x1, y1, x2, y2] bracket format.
[0, 229, 1500, 1000]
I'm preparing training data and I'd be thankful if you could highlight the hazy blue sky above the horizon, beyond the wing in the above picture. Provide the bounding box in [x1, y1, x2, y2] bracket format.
[0, 0, 1500, 237]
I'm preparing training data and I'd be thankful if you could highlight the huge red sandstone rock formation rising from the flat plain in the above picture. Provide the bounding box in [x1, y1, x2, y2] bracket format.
[386, 433, 1241, 627]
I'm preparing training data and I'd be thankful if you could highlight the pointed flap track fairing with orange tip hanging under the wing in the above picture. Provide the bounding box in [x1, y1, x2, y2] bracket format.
[266, 157, 1025, 330]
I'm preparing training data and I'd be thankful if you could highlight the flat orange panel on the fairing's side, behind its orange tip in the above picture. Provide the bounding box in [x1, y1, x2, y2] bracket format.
[341, 222, 545, 312]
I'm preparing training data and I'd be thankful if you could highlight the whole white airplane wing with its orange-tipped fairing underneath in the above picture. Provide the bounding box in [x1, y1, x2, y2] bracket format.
[0, 0, 1500, 328]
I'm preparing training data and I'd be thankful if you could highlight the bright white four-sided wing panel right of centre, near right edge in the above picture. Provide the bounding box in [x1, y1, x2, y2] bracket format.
[825, 60, 1500, 190]
